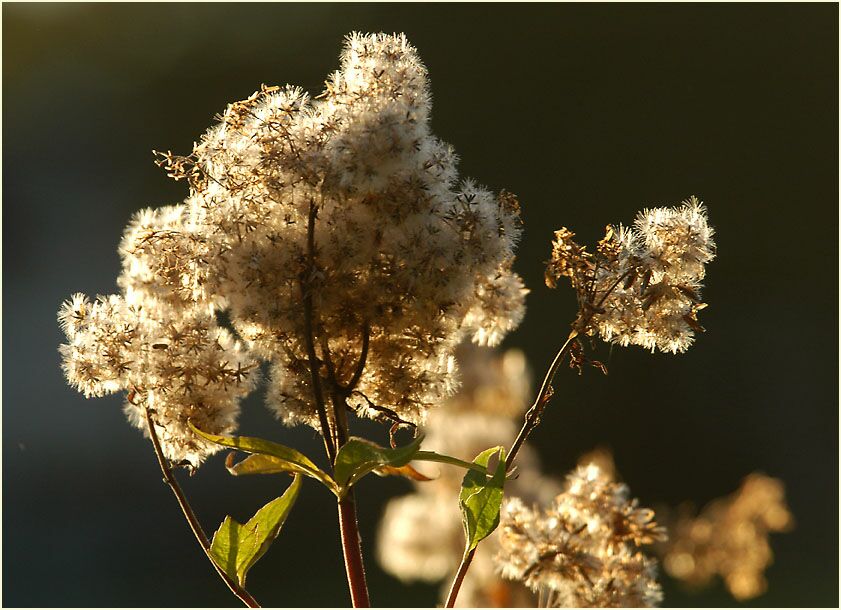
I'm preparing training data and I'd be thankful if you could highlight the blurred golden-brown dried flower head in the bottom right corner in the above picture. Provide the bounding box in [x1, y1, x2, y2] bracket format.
[663, 474, 794, 600]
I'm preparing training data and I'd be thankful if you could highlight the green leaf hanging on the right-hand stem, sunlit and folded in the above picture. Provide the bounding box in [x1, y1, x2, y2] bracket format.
[459, 447, 505, 551]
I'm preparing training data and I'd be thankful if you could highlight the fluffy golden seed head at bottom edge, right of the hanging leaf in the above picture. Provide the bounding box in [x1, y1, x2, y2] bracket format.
[496, 464, 665, 607]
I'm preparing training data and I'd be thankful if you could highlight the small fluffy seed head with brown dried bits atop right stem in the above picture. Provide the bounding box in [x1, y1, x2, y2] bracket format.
[546, 196, 715, 353]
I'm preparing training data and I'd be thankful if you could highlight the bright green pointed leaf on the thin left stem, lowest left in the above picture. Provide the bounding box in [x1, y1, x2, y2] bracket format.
[210, 474, 301, 587]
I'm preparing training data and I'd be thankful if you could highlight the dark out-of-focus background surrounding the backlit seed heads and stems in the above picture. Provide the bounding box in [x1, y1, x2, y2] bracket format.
[2, 4, 839, 606]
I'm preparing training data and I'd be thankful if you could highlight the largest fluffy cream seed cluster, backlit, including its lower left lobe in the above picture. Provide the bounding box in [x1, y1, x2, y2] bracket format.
[60, 34, 526, 463]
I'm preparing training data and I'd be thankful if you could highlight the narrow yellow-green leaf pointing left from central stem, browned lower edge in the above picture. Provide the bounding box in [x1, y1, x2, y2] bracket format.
[190, 423, 338, 495]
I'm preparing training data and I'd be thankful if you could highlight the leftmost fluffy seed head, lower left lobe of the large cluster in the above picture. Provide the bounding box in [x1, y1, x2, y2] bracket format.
[59, 294, 257, 467]
